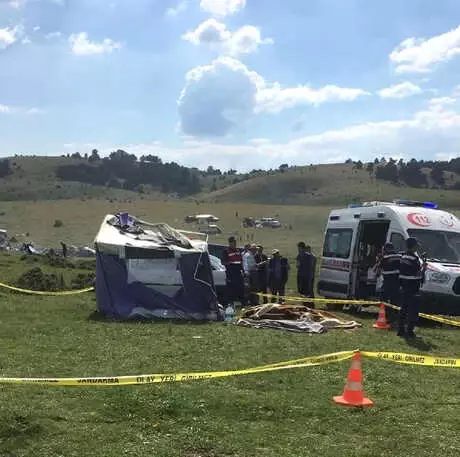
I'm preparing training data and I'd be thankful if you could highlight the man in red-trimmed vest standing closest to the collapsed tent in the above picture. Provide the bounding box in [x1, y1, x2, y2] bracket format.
[222, 236, 244, 306]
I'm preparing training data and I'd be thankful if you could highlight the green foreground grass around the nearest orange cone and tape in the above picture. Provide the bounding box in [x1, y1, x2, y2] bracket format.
[0, 251, 460, 457]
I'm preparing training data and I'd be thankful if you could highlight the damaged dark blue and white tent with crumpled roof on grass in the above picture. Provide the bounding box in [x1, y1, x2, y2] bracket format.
[95, 213, 221, 320]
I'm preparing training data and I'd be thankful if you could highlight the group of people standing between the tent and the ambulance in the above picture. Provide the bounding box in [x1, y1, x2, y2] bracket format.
[222, 236, 316, 306]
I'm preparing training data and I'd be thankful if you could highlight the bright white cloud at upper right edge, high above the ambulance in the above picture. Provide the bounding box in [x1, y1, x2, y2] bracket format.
[390, 26, 460, 73]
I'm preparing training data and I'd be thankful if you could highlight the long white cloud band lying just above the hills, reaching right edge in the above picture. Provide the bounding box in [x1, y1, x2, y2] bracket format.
[64, 102, 460, 171]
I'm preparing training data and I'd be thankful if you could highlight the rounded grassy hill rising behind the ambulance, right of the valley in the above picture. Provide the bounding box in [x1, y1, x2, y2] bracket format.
[204, 164, 460, 208]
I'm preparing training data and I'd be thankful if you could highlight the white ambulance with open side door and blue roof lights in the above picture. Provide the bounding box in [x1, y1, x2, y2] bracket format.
[318, 200, 460, 315]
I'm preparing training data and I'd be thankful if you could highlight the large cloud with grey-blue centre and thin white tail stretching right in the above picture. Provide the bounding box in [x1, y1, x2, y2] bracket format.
[178, 56, 368, 136]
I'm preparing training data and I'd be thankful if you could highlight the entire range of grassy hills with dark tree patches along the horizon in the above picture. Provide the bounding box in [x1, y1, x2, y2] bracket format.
[0, 156, 460, 208]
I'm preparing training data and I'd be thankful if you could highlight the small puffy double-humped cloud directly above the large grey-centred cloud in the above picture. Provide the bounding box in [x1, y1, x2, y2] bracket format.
[182, 18, 273, 56]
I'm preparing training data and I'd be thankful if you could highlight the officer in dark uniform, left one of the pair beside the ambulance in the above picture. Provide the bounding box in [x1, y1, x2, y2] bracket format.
[377, 243, 401, 321]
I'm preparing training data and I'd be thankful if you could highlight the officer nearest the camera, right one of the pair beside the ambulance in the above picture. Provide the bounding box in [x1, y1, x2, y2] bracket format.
[398, 237, 425, 338]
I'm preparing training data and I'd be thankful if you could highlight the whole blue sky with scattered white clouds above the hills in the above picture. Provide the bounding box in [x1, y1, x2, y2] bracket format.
[0, 0, 460, 171]
